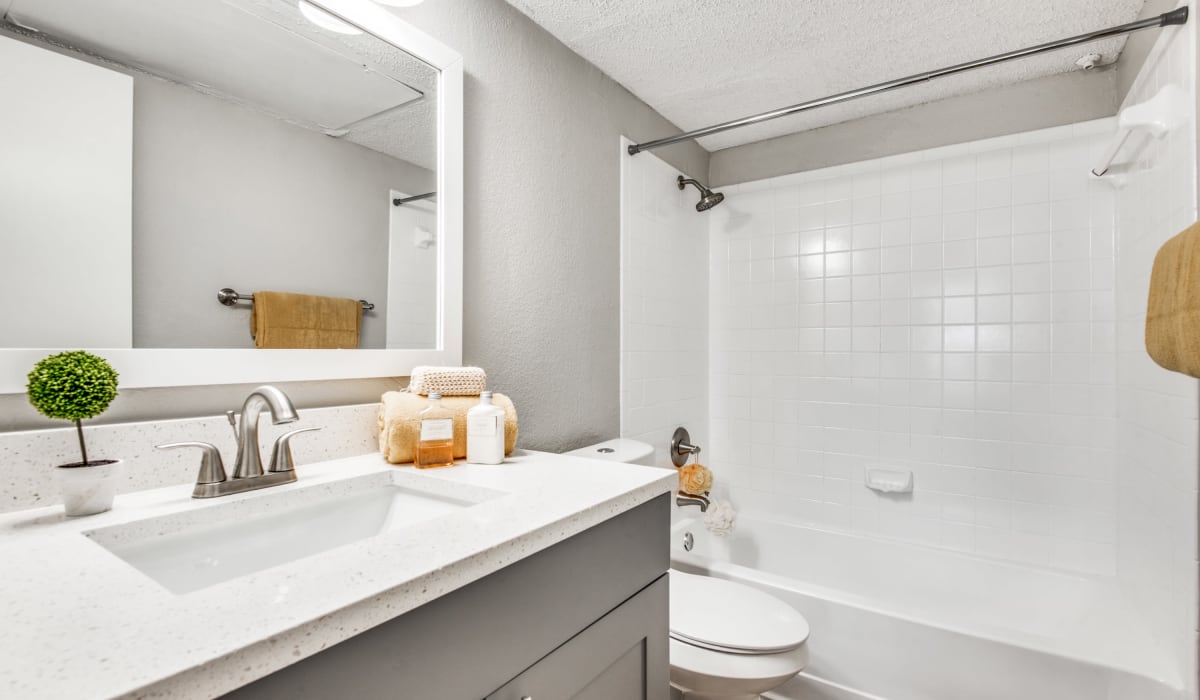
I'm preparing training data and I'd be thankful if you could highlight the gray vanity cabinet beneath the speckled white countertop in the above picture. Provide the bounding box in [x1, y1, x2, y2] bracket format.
[227, 495, 670, 700]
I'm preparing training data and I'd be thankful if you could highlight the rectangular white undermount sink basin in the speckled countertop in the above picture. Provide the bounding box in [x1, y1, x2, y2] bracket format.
[84, 469, 503, 593]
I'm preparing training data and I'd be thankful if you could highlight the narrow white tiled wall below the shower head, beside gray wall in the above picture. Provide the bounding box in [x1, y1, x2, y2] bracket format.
[620, 139, 710, 467]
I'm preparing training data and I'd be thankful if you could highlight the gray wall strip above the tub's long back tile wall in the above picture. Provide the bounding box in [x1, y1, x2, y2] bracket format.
[708, 67, 1117, 187]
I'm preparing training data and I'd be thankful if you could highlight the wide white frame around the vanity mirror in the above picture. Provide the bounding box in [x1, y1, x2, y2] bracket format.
[0, 0, 463, 394]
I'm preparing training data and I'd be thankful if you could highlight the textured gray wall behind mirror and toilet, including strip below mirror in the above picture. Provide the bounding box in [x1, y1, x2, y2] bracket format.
[0, 0, 708, 450]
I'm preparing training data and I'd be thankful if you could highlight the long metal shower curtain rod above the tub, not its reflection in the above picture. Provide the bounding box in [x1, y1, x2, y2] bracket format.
[629, 6, 1188, 156]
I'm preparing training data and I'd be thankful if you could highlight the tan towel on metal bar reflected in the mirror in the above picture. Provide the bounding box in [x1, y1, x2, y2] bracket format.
[250, 292, 362, 349]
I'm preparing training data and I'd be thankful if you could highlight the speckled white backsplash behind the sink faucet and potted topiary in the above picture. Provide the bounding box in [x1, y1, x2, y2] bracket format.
[0, 403, 379, 513]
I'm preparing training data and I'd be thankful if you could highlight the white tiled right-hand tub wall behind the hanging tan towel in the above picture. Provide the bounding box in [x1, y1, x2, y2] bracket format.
[1116, 8, 1200, 698]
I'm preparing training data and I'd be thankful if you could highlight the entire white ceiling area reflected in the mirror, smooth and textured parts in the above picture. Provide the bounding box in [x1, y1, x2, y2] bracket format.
[6, 0, 437, 169]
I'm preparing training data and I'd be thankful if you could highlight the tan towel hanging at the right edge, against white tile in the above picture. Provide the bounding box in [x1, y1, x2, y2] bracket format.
[1146, 223, 1200, 377]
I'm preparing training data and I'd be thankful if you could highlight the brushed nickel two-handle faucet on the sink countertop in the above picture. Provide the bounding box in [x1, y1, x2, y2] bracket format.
[155, 384, 320, 498]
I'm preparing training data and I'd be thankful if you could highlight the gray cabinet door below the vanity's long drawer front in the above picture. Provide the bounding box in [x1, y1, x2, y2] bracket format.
[485, 576, 670, 700]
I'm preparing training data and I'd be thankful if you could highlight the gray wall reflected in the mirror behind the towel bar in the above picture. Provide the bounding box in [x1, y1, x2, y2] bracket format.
[133, 76, 437, 348]
